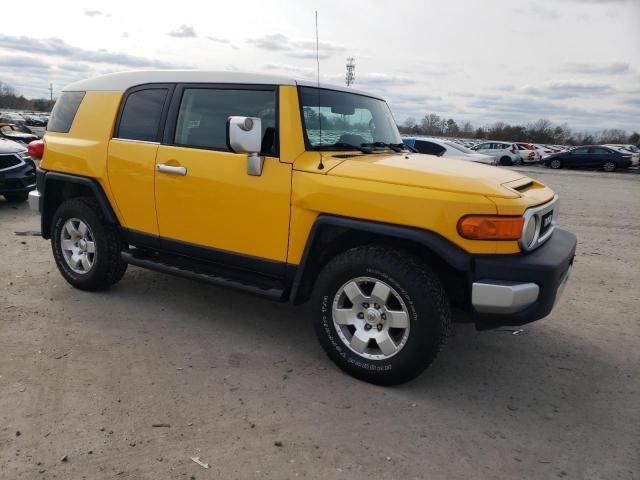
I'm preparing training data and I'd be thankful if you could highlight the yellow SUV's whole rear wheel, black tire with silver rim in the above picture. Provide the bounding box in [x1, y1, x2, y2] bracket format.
[51, 197, 127, 291]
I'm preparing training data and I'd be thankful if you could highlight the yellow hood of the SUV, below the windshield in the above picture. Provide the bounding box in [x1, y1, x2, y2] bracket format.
[327, 153, 527, 198]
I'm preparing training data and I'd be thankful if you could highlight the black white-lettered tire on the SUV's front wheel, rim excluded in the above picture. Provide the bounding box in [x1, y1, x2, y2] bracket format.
[312, 245, 451, 385]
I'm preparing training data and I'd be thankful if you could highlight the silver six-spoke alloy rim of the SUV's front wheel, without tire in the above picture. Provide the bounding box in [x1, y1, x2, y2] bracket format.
[331, 277, 410, 360]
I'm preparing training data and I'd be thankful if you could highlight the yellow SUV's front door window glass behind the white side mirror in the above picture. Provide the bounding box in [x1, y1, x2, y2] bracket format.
[174, 88, 277, 155]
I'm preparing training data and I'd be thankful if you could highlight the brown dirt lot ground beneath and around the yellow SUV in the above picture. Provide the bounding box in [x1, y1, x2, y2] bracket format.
[0, 168, 640, 480]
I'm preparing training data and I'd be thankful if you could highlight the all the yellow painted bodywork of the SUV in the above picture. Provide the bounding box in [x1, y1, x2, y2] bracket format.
[41, 86, 553, 264]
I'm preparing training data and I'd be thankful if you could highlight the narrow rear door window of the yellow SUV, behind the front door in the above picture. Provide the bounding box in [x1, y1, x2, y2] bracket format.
[115, 88, 168, 142]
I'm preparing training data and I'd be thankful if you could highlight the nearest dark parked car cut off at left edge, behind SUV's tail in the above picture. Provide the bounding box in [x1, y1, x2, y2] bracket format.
[0, 138, 36, 202]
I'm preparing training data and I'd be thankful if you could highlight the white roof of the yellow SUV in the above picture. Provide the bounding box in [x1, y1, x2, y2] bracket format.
[62, 70, 378, 98]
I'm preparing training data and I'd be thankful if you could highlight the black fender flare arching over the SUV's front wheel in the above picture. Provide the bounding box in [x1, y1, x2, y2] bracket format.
[289, 214, 472, 304]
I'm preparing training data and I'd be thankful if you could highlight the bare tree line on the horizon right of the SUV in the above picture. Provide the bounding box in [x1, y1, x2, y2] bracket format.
[398, 113, 640, 145]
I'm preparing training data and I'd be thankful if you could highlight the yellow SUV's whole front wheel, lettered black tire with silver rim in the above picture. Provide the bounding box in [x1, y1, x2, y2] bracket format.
[313, 245, 450, 385]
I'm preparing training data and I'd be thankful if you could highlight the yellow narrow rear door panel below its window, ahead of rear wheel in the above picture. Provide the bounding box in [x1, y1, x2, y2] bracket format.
[107, 140, 158, 235]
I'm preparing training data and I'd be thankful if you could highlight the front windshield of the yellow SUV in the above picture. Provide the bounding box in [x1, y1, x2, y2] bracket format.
[298, 87, 402, 150]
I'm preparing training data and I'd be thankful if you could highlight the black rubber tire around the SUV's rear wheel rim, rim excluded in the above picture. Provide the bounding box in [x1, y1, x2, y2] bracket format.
[51, 197, 127, 291]
